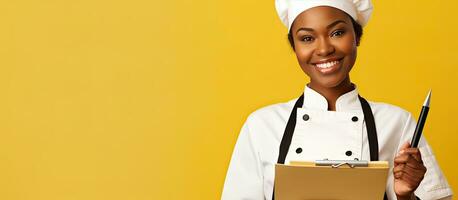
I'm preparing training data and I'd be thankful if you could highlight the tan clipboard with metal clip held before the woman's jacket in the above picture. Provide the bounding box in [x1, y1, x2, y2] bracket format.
[275, 160, 389, 200]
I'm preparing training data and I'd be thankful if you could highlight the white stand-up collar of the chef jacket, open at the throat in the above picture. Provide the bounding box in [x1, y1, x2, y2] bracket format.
[303, 86, 361, 111]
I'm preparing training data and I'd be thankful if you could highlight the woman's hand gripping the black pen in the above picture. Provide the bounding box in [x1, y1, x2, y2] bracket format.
[393, 142, 426, 200]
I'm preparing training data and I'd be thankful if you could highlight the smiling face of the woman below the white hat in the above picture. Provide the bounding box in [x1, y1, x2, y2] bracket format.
[291, 6, 357, 89]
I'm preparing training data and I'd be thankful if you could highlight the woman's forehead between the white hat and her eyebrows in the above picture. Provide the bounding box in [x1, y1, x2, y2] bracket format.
[291, 6, 351, 30]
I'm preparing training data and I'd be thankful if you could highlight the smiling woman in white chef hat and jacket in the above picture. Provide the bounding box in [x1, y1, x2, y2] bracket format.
[222, 0, 452, 200]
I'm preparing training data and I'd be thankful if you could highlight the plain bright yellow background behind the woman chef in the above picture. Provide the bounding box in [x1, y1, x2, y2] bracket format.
[0, 0, 458, 200]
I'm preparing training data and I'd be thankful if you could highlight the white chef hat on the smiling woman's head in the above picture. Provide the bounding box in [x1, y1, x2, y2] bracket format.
[275, 0, 373, 32]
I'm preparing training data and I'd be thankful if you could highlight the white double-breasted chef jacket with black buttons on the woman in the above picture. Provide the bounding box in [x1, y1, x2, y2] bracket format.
[222, 87, 452, 200]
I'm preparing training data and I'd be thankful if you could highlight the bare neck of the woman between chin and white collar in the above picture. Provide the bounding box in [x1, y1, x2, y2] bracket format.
[308, 77, 355, 111]
